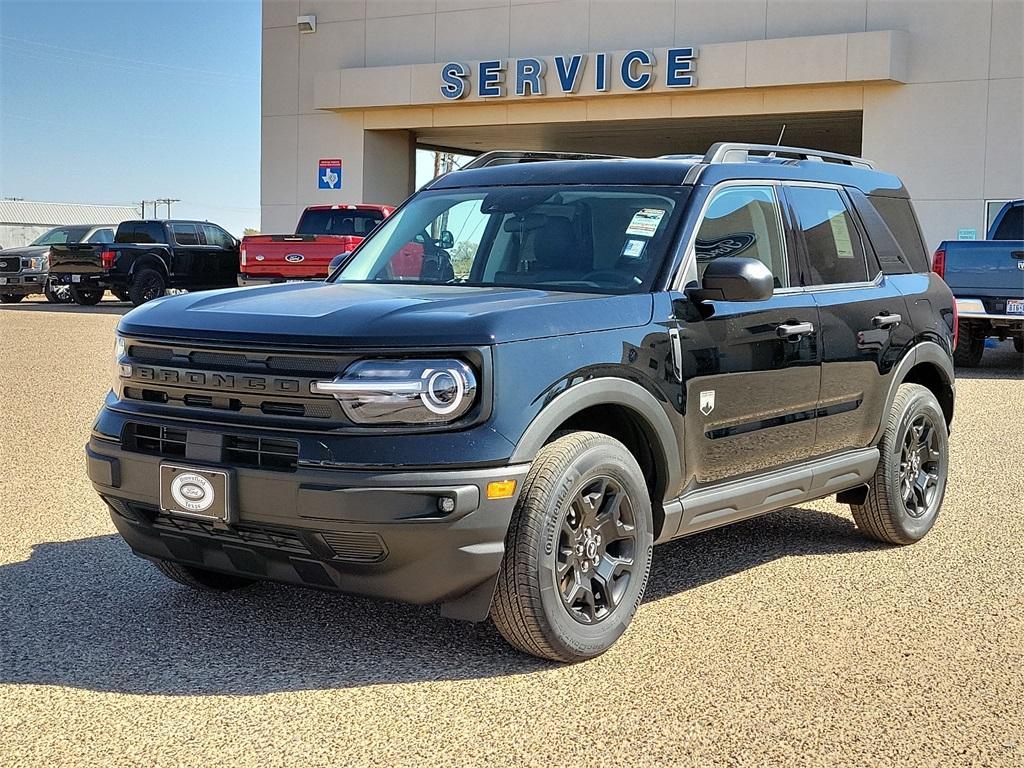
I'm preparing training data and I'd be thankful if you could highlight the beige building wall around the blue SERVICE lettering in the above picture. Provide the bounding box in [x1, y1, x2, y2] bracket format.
[262, 0, 1024, 245]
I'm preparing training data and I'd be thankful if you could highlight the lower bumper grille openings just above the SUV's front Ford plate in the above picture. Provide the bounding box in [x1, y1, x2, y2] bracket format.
[121, 422, 299, 472]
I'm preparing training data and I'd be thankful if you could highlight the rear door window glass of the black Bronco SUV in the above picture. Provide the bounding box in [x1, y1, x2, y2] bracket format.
[786, 186, 867, 286]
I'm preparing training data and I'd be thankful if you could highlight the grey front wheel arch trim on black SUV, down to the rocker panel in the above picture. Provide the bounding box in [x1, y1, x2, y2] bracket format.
[510, 378, 682, 538]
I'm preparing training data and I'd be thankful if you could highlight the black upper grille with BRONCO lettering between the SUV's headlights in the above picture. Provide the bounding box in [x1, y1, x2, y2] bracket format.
[121, 341, 356, 428]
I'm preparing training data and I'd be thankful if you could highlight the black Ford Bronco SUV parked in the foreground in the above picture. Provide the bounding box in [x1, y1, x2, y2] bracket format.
[88, 144, 955, 662]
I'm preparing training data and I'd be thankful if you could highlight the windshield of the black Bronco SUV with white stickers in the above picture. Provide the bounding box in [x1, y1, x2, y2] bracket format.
[332, 185, 688, 293]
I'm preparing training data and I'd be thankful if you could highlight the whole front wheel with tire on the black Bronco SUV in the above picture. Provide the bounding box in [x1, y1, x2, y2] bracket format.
[490, 432, 654, 662]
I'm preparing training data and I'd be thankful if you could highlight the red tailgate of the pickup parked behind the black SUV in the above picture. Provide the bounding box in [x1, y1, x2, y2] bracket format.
[242, 234, 362, 280]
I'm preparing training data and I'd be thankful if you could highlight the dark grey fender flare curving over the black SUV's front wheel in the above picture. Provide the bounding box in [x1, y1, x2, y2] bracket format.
[509, 377, 683, 501]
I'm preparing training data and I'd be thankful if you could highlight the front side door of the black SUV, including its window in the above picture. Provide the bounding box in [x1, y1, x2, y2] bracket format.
[675, 182, 821, 486]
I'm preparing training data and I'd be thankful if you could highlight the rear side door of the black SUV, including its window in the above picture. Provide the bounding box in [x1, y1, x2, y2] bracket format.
[784, 182, 912, 456]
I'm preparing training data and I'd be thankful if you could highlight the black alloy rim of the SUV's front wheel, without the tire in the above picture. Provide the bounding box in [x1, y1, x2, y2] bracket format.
[554, 477, 637, 624]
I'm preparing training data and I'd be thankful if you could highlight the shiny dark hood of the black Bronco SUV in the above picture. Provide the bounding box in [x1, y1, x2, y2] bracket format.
[118, 283, 653, 347]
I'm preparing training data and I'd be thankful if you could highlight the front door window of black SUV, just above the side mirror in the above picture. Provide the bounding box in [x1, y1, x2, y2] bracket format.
[694, 186, 791, 288]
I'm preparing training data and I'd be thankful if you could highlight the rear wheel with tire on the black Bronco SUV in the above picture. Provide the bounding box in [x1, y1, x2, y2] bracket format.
[850, 384, 949, 544]
